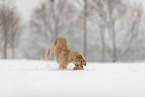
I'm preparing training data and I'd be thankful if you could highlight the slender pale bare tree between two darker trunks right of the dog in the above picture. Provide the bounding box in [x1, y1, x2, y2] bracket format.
[89, 0, 107, 62]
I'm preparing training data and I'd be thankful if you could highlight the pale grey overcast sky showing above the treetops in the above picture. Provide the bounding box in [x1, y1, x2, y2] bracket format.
[14, 0, 145, 21]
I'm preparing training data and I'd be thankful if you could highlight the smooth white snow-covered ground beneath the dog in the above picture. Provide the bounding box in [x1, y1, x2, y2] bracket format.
[0, 60, 145, 97]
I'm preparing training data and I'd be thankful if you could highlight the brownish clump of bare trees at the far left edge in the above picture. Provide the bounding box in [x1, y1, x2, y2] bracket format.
[0, 0, 21, 59]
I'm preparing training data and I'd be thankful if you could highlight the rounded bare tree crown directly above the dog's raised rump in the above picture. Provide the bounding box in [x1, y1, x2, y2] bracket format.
[30, 0, 75, 59]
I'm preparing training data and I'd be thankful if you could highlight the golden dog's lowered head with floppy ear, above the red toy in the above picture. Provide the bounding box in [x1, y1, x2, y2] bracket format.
[74, 52, 87, 68]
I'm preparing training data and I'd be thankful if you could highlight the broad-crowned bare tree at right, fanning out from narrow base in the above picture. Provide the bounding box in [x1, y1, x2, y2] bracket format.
[107, 0, 142, 62]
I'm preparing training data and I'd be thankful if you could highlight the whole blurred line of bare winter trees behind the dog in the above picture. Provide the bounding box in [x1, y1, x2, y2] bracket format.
[0, 0, 145, 62]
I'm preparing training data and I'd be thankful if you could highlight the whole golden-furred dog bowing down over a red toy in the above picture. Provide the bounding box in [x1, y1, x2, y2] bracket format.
[45, 37, 87, 69]
